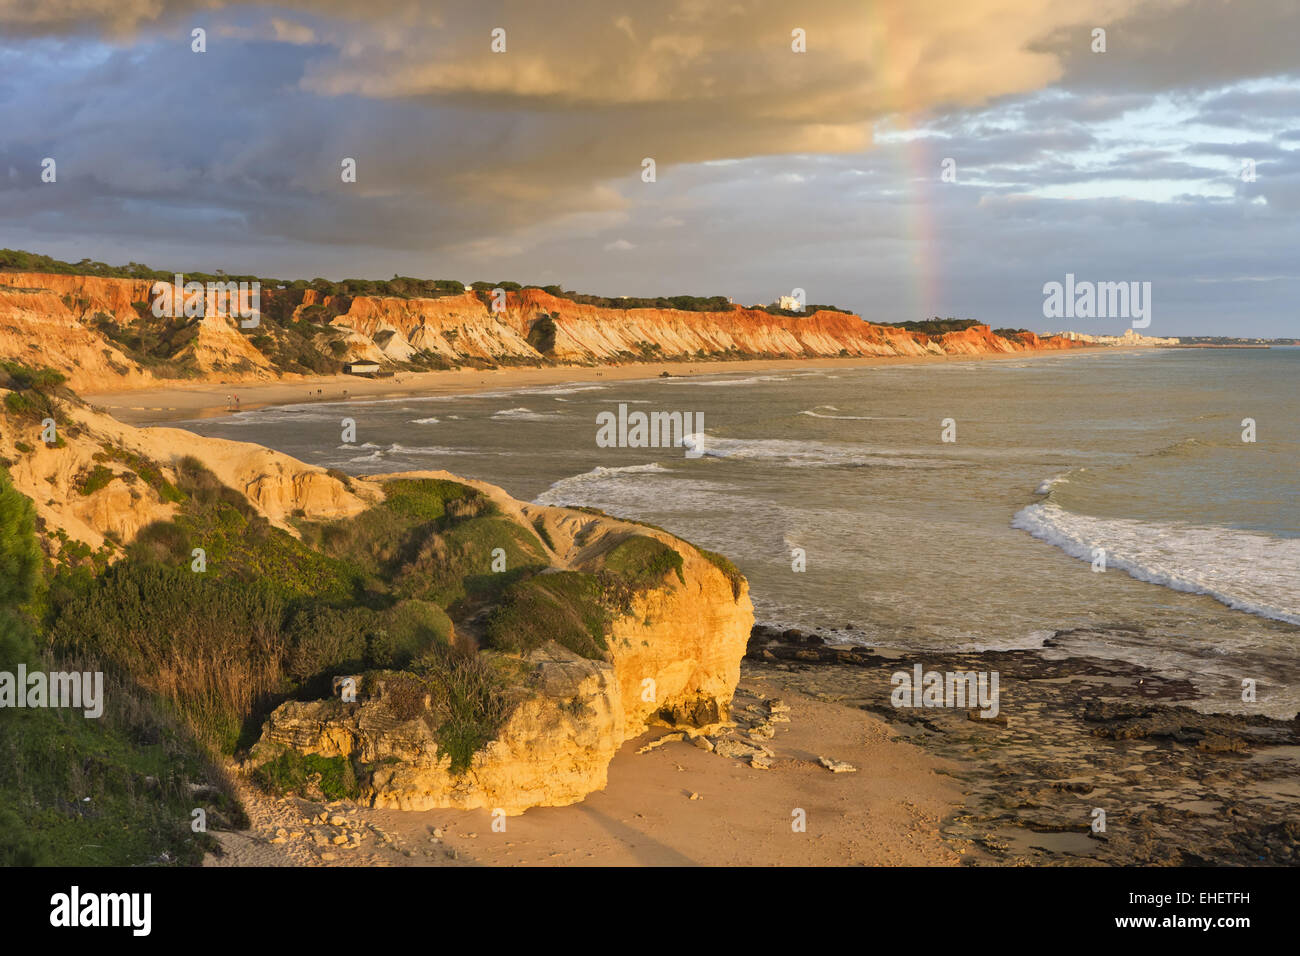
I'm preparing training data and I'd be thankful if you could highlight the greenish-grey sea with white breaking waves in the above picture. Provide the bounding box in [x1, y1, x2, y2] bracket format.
[172, 349, 1300, 718]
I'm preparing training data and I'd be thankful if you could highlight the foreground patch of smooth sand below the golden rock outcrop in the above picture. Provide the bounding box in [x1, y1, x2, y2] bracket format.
[204, 674, 962, 866]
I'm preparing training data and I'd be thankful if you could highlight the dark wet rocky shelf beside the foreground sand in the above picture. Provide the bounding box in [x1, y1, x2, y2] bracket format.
[744, 623, 1300, 866]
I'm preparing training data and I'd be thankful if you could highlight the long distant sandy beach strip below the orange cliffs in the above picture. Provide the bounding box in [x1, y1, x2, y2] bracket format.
[82, 346, 1128, 425]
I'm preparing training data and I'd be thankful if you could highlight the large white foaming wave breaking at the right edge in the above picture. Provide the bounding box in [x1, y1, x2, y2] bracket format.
[1011, 501, 1300, 624]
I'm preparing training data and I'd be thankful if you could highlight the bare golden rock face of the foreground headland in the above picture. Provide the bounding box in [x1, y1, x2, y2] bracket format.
[252, 489, 754, 814]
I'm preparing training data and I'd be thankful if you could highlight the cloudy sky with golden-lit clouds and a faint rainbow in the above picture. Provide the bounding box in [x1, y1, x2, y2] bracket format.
[0, 0, 1300, 337]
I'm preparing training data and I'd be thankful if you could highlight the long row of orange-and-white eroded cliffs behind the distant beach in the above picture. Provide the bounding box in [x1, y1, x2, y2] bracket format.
[0, 273, 1083, 390]
